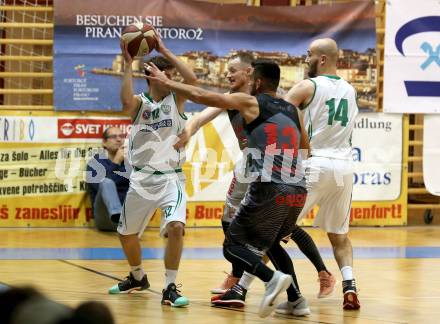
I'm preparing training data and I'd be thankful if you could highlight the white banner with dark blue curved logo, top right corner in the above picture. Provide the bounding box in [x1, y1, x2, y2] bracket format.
[383, 0, 440, 113]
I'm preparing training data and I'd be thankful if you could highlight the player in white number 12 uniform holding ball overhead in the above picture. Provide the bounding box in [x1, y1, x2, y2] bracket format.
[109, 36, 197, 307]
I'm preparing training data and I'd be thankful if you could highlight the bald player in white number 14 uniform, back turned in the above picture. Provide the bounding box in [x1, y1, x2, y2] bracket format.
[277, 38, 360, 312]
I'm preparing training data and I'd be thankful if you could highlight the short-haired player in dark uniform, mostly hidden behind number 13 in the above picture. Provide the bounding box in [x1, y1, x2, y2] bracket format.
[175, 52, 335, 306]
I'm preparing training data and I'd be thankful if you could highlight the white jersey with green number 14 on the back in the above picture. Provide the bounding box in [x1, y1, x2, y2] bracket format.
[304, 75, 358, 160]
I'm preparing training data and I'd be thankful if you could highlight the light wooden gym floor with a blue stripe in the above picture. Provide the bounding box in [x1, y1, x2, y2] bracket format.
[0, 227, 440, 324]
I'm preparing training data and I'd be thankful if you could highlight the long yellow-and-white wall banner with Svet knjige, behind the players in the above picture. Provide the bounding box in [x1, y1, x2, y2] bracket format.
[0, 112, 407, 227]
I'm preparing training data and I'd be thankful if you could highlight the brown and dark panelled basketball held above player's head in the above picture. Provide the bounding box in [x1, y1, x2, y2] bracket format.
[121, 23, 157, 57]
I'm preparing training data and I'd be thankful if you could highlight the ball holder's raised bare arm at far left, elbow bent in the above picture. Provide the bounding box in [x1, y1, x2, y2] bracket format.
[120, 41, 141, 119]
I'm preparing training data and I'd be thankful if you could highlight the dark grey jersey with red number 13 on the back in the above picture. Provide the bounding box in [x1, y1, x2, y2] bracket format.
[245, 93, 305, 186]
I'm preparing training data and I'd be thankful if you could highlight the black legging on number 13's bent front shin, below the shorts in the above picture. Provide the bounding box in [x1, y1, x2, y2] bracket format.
[223, 243, 274, 282]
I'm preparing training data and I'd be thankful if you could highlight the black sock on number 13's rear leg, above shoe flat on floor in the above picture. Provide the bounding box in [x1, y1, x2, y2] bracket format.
[267, 243, 301, 301]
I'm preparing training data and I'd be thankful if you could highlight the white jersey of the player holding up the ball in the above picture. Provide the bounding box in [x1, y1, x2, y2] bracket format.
[129, 92, 187, 174]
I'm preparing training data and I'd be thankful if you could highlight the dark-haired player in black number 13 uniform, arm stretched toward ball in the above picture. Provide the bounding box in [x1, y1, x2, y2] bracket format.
[147, 61, 308, 317]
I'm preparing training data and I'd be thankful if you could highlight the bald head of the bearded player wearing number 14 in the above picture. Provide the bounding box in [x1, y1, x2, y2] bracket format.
[306, 38, 339, 78]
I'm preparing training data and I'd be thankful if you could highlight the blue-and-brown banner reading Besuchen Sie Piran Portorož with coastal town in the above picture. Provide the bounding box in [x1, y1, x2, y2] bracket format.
[54, 0, 377, 111]
